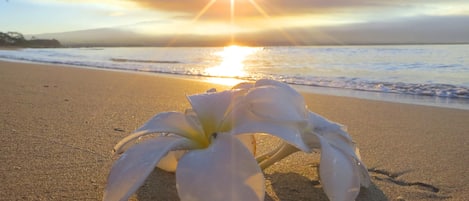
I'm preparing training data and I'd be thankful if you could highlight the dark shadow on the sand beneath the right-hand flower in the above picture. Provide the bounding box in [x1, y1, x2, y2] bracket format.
[265, 172, 389, 201]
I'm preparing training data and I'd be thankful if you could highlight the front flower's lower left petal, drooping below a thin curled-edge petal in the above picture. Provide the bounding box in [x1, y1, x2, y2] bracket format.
[103, 136, 187, 201]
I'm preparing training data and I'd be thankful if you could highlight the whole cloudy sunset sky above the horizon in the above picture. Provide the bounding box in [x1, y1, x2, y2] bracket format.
[0, 0, 469, 45]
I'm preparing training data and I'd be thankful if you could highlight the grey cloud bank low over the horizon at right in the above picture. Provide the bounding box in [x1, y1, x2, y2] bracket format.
[251, 15, 469, 45]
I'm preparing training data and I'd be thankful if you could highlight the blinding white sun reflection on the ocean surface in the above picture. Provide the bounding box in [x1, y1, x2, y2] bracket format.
[205, 45, 259, 78]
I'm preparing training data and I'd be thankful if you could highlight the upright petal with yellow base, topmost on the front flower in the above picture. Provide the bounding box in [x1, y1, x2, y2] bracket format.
[187, 90, 233, 135]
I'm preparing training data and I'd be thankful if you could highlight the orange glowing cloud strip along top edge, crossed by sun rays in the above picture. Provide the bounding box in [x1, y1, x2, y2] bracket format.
[130, 0, 469, 20]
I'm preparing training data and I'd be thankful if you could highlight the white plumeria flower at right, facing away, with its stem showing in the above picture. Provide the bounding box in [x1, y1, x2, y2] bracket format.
[234, 80, 370, 201]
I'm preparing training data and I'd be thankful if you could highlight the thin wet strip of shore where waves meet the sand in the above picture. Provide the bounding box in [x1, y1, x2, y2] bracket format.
[0, 59, 469, 110]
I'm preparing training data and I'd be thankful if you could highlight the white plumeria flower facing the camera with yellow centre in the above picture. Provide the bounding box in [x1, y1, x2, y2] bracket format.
[104, 90, 265, 201]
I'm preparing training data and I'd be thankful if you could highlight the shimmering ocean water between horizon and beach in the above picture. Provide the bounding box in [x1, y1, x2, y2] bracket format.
[0, 45, 469, 109]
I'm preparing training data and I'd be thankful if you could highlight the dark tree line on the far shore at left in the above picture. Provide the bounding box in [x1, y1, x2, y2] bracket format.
[0, 32, 62, 48]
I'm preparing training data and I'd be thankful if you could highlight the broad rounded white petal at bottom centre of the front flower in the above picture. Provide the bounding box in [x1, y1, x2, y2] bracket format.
[176, 133, 265, 201]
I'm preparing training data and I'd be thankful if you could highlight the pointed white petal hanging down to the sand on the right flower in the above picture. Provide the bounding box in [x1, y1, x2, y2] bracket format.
[318, 136, 360, 201]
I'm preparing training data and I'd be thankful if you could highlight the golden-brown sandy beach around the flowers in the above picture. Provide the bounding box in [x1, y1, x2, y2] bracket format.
[0, 61, 469, 201]
